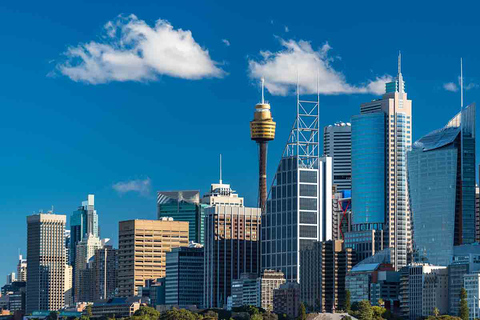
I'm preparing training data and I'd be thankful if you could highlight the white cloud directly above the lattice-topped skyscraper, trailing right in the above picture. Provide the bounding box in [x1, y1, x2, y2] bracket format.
[248, 39, 392, 95]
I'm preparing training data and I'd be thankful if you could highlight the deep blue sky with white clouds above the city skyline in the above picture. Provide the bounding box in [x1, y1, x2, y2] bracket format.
[0, 0, 480, 283]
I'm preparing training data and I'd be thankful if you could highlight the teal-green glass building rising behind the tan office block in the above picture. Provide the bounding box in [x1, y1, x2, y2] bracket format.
[157, 190, 205, 244]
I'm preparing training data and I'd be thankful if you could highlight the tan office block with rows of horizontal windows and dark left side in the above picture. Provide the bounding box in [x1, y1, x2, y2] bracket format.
[117, 218, 188, 297]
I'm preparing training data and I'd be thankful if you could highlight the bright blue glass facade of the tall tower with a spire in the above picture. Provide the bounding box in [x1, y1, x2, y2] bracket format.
[352, 112, 386, 229]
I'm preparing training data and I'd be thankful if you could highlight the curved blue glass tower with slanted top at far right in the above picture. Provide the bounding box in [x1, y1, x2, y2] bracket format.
[407, 104, 475, 266]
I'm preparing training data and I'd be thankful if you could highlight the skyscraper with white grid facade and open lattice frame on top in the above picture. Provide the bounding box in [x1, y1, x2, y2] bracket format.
[262, 88, 333, 282]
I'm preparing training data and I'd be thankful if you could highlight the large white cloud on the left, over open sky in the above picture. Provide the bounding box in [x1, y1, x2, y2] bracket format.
[57, 15, 225, 84]
